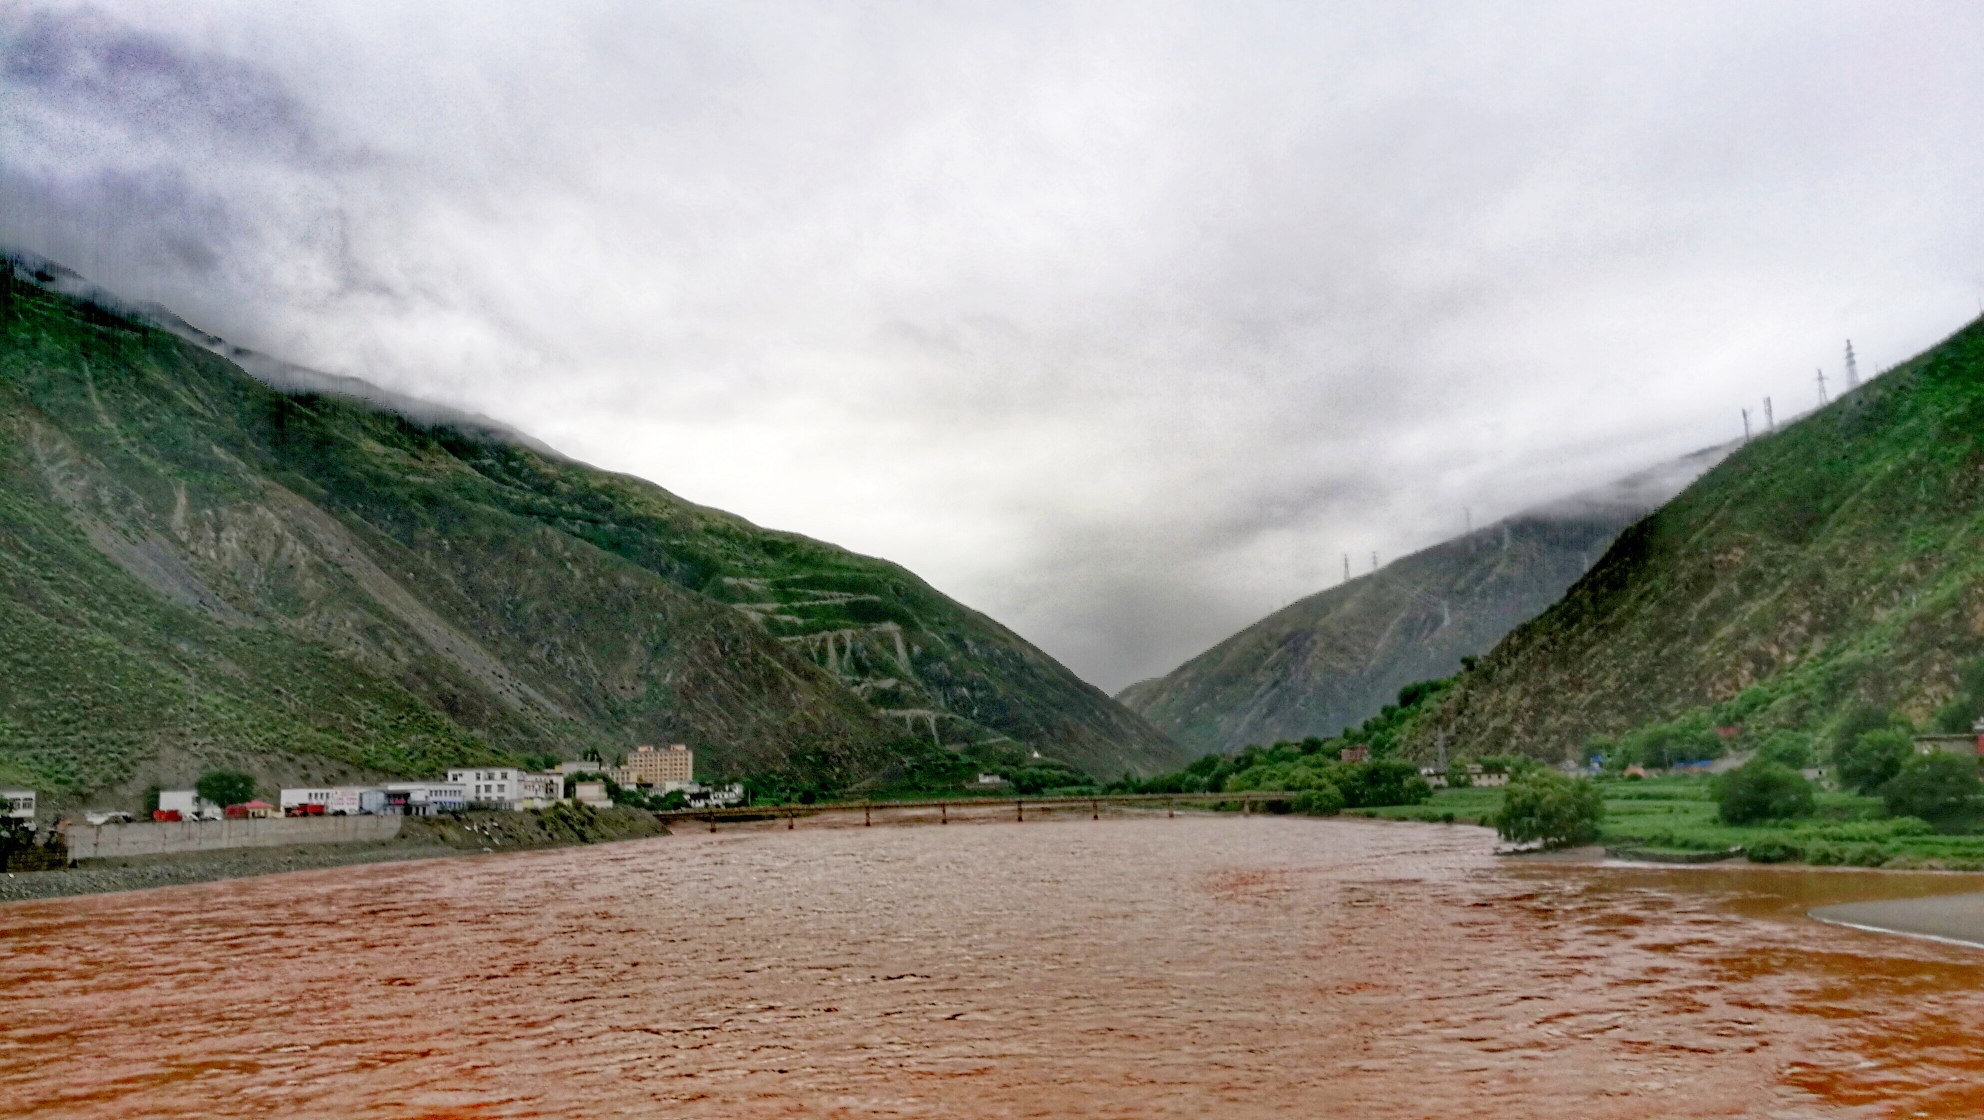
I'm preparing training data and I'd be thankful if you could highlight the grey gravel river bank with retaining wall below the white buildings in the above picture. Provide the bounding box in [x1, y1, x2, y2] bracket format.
[0, 805, 669, 902]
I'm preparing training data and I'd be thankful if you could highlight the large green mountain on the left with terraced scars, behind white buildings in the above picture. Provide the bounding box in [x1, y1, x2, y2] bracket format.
[0, 260, 1186, 797]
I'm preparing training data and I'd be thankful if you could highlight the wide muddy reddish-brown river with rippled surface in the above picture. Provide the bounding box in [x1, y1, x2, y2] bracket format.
[0, 815, 1984, 1120]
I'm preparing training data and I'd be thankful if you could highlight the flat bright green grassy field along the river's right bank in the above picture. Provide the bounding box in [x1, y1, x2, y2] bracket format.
[1351, 777, 1984, 870]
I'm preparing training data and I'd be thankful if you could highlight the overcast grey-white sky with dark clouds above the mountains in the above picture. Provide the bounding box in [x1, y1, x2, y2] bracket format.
[0, 0, 1984, 692]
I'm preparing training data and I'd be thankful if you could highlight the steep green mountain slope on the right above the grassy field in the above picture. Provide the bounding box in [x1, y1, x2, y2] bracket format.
[1417, 321, 1984, 757]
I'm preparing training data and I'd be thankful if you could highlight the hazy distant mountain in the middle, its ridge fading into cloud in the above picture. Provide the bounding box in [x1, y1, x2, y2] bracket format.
[1117, 446, 1730, 753]
